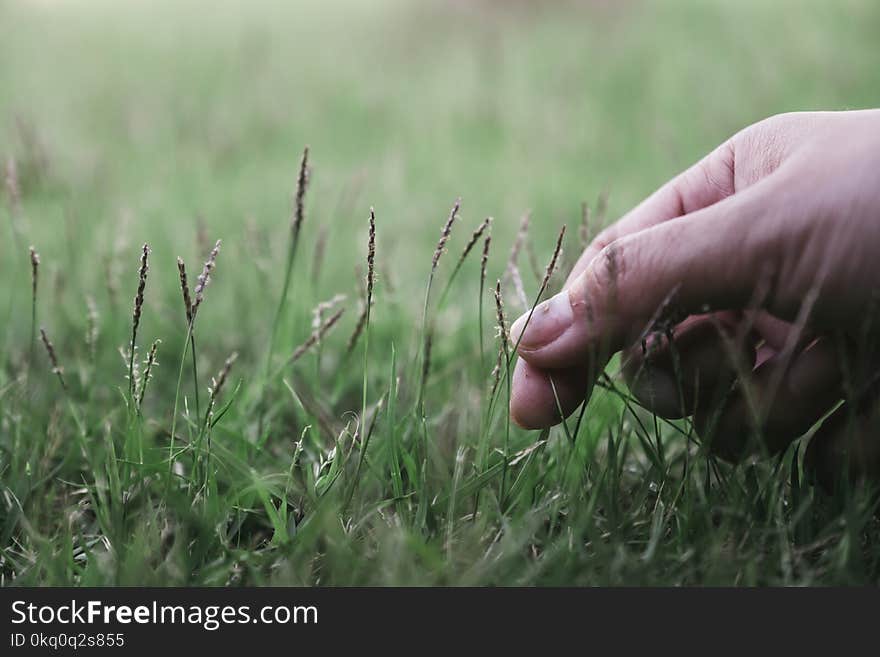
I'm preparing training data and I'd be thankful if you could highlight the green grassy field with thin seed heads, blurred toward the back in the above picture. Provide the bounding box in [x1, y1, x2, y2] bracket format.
[0, 0, 880, 585]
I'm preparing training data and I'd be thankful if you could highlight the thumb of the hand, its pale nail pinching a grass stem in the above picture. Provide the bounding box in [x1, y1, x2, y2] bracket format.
[511, 176, 797, 368]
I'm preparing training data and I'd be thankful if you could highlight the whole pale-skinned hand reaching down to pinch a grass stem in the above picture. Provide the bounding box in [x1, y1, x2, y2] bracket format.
[510, 110, 880, 483]
